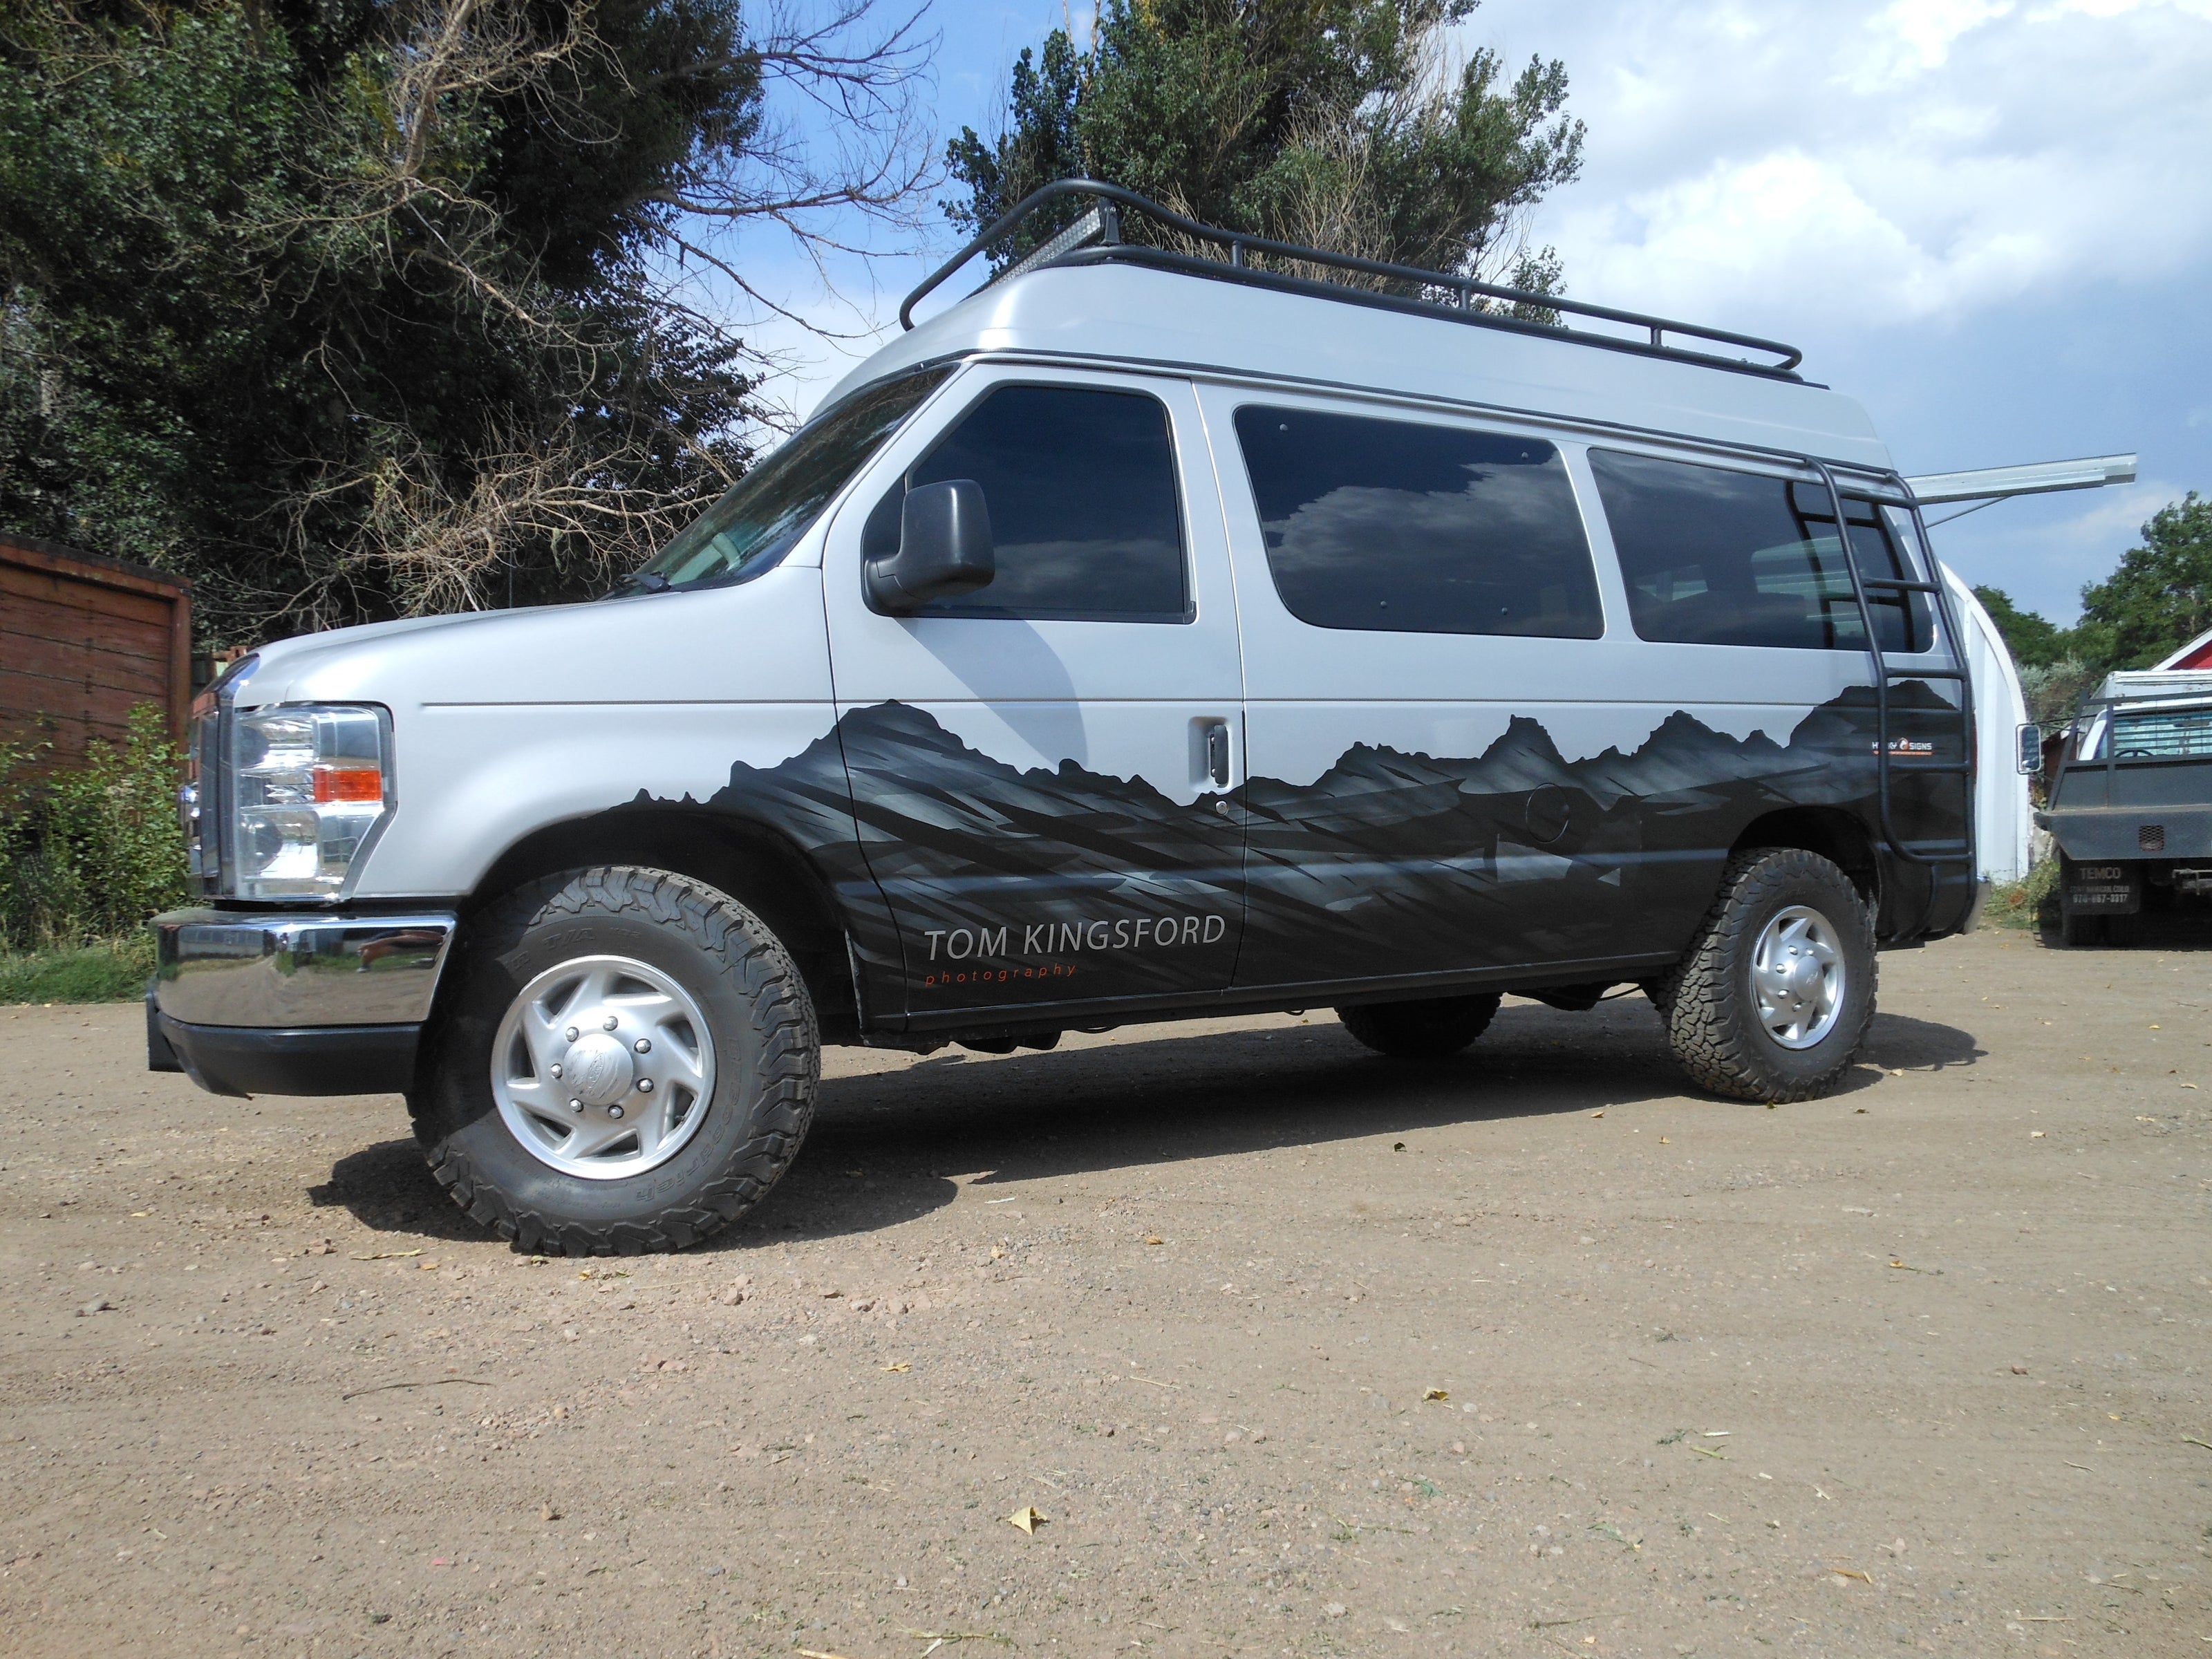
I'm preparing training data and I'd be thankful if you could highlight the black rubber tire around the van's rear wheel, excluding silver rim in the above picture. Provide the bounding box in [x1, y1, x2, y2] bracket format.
[1646, 847, 1873, 1106]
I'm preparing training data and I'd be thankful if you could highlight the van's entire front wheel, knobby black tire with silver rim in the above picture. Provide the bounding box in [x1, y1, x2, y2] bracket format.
[409, 865, 821, 1257]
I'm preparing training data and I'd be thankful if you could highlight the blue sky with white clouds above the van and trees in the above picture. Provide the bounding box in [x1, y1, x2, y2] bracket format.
[721, 0, 2212, 624]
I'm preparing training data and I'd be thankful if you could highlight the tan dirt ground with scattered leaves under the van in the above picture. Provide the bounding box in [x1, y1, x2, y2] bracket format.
[0, 933, 2212, 1659]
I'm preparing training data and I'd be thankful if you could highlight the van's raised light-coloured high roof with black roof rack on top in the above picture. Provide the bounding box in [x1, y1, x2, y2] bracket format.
[830, 179, 1891, 474]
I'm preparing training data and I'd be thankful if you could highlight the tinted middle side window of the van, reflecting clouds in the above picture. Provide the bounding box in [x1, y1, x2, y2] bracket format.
[1237, 405, 1606, 639]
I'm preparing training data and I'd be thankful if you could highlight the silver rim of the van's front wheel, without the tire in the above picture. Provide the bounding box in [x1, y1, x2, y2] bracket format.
[491, 955, 715, 1181]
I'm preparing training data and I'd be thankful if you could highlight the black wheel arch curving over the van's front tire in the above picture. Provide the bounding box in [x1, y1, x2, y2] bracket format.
[462, 803, 859, 1042]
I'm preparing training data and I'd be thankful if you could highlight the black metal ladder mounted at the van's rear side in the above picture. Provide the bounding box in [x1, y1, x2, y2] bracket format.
[1805, 456, 1980, 931]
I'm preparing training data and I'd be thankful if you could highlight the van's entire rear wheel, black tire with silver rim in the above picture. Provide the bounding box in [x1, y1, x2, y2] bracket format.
[1650, 847, 1873, 1104]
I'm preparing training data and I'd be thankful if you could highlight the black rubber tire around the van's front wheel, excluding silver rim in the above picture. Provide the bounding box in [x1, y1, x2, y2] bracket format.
[407, 865, 821, 1257]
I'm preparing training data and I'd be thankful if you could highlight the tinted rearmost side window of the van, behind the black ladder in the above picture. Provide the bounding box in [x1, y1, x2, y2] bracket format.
[1591, 449, 1927, 653]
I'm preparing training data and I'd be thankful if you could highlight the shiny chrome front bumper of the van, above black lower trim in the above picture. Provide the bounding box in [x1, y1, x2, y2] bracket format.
[153, 909, 456, 1027]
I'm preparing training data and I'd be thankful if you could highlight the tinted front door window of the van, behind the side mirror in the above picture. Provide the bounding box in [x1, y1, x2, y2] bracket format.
[861, 385, 1192, 621]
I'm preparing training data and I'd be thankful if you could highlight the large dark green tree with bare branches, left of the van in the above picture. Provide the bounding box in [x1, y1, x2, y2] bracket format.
[0, 0, 925, 644]
